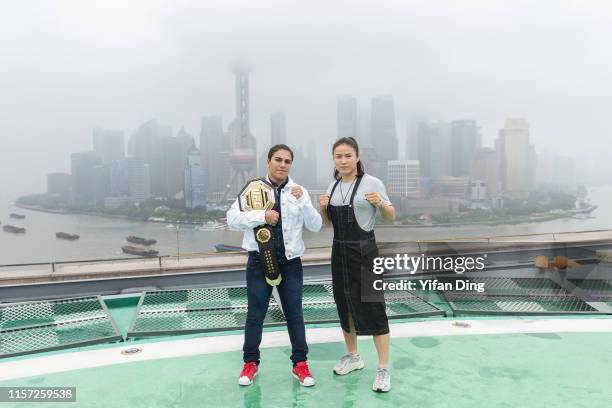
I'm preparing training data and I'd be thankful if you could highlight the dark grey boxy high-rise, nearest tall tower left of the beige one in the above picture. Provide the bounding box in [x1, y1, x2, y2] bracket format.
[450, 120, 482, 177]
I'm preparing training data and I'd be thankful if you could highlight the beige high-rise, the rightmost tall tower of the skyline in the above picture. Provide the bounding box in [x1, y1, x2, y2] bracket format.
[496, 118, 535, 198]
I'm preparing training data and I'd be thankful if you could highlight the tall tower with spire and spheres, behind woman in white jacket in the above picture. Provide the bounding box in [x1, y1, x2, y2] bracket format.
[224, 68, 257, 201]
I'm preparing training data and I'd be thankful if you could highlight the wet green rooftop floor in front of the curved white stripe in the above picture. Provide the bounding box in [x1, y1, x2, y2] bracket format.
[0, 333, 612, 408]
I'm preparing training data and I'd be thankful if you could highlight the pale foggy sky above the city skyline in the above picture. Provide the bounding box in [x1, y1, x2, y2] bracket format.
[0, 0, 612, 198]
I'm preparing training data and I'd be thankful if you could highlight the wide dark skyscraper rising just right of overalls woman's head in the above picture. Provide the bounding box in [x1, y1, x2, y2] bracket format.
[370, 96, 398, 182]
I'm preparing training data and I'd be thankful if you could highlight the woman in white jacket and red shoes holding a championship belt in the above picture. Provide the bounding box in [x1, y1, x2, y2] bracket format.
[227, 144, 322, 387]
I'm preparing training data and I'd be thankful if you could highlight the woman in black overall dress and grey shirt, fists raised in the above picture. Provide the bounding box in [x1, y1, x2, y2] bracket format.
[319, 138, 395, 392]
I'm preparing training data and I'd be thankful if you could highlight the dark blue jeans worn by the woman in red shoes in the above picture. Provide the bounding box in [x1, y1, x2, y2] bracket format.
[242, 252, 308, 365]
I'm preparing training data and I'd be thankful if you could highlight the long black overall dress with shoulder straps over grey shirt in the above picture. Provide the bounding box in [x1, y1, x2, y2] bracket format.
[327, 176, 389, 335]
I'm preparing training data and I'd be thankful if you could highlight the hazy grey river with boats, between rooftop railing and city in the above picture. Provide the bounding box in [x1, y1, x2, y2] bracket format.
[0, 185, 612, 265]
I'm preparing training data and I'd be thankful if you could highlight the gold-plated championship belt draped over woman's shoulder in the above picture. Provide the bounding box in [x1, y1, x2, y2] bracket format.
[238, 179, 282, 286]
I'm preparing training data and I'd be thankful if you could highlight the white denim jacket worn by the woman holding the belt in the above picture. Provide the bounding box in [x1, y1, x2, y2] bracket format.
[227, 176, 322, 259]
